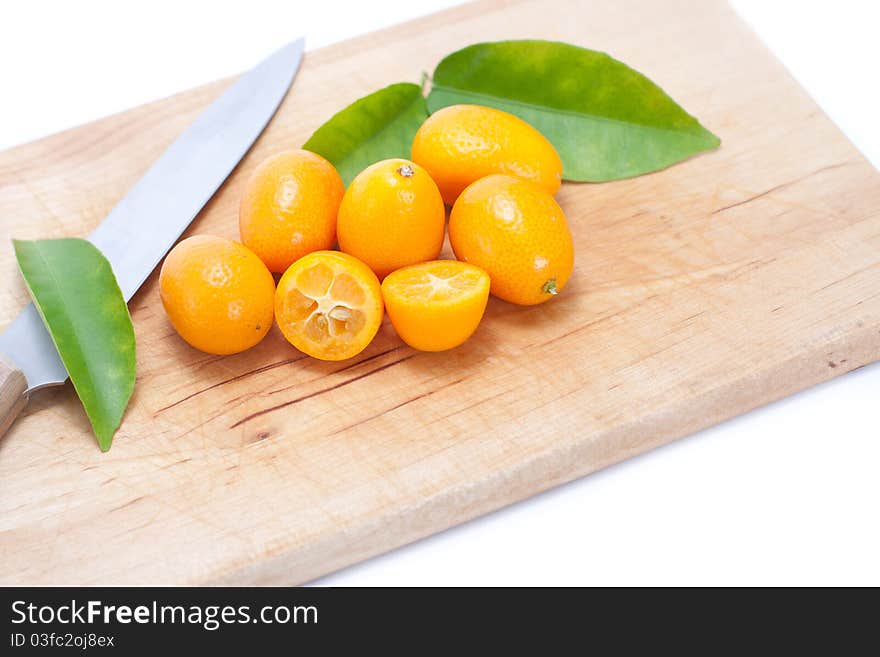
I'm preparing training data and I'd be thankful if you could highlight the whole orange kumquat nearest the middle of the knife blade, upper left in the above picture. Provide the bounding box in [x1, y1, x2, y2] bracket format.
[238, 150, 344, 273]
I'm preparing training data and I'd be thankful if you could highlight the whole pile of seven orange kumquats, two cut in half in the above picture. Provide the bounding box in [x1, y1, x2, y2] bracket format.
[159, 105, 574, 360]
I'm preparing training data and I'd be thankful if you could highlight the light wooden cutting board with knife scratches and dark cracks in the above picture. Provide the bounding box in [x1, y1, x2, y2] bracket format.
[0, 0, 880, 584]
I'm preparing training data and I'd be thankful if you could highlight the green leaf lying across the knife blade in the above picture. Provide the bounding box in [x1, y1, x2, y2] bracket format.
[13, 239, 135, 452]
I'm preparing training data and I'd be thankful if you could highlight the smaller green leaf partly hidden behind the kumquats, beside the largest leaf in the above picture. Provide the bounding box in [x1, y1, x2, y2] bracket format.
[303, 82, 428, 187]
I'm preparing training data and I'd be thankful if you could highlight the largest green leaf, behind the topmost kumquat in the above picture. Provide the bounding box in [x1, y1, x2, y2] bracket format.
[428, 41, 721, 182]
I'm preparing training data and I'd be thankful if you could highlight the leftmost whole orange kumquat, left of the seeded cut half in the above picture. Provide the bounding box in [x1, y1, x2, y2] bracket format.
[159, 235, 275, 355]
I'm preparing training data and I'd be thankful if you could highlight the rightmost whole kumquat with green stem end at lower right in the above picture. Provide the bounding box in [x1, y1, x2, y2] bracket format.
[449, 174, 574, 305]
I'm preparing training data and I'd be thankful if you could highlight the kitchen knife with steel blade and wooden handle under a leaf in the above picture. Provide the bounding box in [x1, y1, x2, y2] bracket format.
[0, 39, 304, 436]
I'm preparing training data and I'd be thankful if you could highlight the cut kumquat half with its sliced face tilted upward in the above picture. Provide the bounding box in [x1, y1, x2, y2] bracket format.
[382, 260, 489, 351]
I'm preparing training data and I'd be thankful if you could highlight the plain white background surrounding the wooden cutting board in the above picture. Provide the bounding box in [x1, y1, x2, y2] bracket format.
[0, 0, 880, 585]
